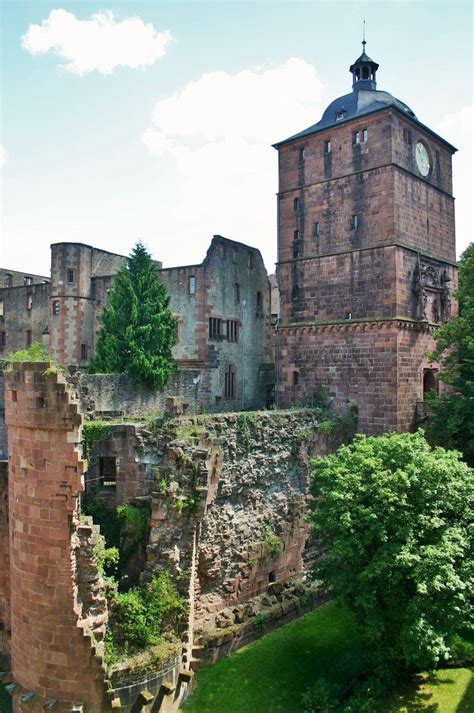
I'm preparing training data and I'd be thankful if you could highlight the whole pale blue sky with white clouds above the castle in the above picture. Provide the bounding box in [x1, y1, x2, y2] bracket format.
[0, 0, 473, 275]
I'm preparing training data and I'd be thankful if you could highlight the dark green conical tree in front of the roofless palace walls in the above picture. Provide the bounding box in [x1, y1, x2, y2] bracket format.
[89, 242, 176, 389]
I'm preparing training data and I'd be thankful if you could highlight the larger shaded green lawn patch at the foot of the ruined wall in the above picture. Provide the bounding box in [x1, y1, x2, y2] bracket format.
[182, 602, 364, 713]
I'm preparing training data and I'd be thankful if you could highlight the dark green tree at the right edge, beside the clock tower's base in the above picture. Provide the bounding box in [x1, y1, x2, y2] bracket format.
[426, 243, 474, 466]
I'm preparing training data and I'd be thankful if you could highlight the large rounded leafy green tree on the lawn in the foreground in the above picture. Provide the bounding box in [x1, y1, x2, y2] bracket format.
[310, 431, 474, 677]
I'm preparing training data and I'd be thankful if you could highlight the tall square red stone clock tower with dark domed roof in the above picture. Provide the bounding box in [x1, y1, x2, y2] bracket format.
[275, 42, 456, 433]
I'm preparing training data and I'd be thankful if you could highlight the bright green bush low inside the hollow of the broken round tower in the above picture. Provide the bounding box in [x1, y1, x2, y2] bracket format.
[109, 572, 187, 655]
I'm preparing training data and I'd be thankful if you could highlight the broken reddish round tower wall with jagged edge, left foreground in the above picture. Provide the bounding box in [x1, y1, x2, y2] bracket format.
[6, 363, 107, 713]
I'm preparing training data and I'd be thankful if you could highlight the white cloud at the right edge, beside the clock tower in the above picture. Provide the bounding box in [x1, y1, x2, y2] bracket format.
[436, 105, 474, 255]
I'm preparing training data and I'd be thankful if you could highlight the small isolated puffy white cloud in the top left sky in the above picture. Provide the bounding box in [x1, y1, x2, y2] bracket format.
[21, 9, 172, 76]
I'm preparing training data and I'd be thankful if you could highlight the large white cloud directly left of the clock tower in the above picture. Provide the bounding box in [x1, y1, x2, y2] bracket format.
[143, 58, 321, 269]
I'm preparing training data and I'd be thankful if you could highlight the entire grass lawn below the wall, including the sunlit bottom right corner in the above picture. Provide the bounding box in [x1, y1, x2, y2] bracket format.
[182, 602, 474, 713]
